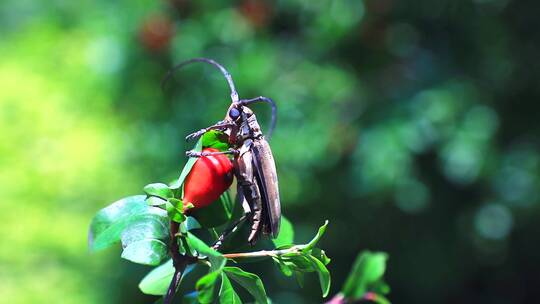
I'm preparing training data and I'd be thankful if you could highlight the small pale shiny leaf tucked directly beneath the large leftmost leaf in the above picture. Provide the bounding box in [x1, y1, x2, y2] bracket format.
[122, 239, 168, 266]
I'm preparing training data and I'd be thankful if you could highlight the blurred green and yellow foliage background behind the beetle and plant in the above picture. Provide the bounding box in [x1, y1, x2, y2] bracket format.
[0, 0, 540, 303]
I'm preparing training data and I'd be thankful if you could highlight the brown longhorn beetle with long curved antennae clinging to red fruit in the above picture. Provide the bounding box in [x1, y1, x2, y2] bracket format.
[164, 58, 281, 249]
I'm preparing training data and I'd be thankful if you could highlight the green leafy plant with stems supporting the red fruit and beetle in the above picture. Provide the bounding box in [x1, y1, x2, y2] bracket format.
[89, 132, 388, 303]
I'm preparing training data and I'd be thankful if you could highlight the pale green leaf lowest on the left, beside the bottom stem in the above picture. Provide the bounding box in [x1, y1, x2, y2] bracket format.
[139, 259, 195, 296]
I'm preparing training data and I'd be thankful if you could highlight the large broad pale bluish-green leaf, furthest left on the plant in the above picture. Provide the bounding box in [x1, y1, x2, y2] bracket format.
[88, 195, 168, 251]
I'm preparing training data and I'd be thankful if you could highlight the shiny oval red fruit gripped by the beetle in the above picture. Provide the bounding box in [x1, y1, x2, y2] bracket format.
[183, 148, 233, 210]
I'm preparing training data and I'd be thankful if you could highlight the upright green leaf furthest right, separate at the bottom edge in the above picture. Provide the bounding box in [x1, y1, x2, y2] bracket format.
[342, 251, 388, 299]
